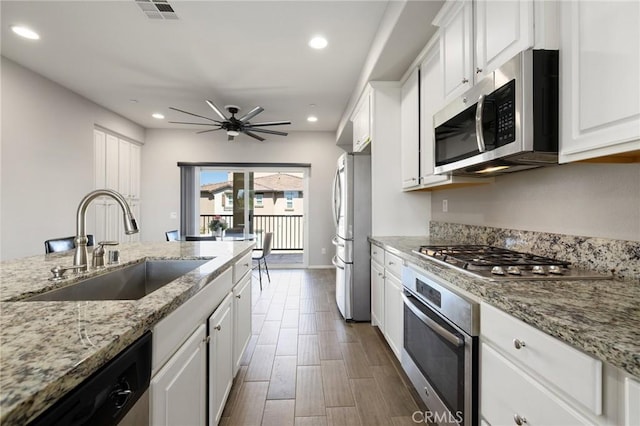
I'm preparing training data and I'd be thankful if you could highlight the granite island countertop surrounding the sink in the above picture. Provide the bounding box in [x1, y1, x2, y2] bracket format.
[0, 242, 254, 425]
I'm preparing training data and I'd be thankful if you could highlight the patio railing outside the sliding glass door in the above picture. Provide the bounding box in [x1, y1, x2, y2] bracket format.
[200, 214, 304, 250]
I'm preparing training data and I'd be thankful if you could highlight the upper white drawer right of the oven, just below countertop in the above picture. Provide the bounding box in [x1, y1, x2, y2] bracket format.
[480, 303, 602, 415]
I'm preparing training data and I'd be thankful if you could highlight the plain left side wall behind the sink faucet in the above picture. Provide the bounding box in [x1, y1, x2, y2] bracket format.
[0, 57, 144, 260]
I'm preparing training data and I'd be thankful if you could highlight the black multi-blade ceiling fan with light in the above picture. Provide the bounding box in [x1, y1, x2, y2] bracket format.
[169, 101, 291, 141]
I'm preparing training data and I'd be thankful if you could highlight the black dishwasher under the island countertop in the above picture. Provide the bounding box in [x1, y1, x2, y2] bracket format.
[30, 332, 151, 426]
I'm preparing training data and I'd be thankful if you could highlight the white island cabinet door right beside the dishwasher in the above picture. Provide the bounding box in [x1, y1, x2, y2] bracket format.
[149, 324, 207, 426]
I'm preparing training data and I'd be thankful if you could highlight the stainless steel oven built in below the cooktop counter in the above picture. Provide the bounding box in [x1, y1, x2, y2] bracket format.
[402, 267, 479, 425]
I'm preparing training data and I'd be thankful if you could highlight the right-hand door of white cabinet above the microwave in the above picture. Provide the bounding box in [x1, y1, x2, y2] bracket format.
[474, 0, 534, 80]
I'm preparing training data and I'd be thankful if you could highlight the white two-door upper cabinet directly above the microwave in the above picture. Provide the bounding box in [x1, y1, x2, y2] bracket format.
[433, 0, 536, 100]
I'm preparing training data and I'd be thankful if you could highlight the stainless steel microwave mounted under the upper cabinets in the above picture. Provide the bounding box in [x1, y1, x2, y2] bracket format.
[433, 49, 559, 176]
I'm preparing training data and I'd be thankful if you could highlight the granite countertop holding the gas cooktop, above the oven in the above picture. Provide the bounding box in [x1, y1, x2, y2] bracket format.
[369, 237, 640, 379]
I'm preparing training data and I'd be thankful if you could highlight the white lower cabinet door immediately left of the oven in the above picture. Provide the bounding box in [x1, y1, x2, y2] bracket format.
[384, 274, 404, 360]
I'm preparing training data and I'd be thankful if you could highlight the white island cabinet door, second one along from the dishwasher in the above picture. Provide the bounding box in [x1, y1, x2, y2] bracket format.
[208, 293, 233, 425]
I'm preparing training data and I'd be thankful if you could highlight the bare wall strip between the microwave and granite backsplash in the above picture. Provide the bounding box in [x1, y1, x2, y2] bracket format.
[431, 163, 640, 241]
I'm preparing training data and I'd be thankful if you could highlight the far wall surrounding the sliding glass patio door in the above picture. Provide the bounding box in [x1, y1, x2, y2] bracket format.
[140, 129, 342, 266]
